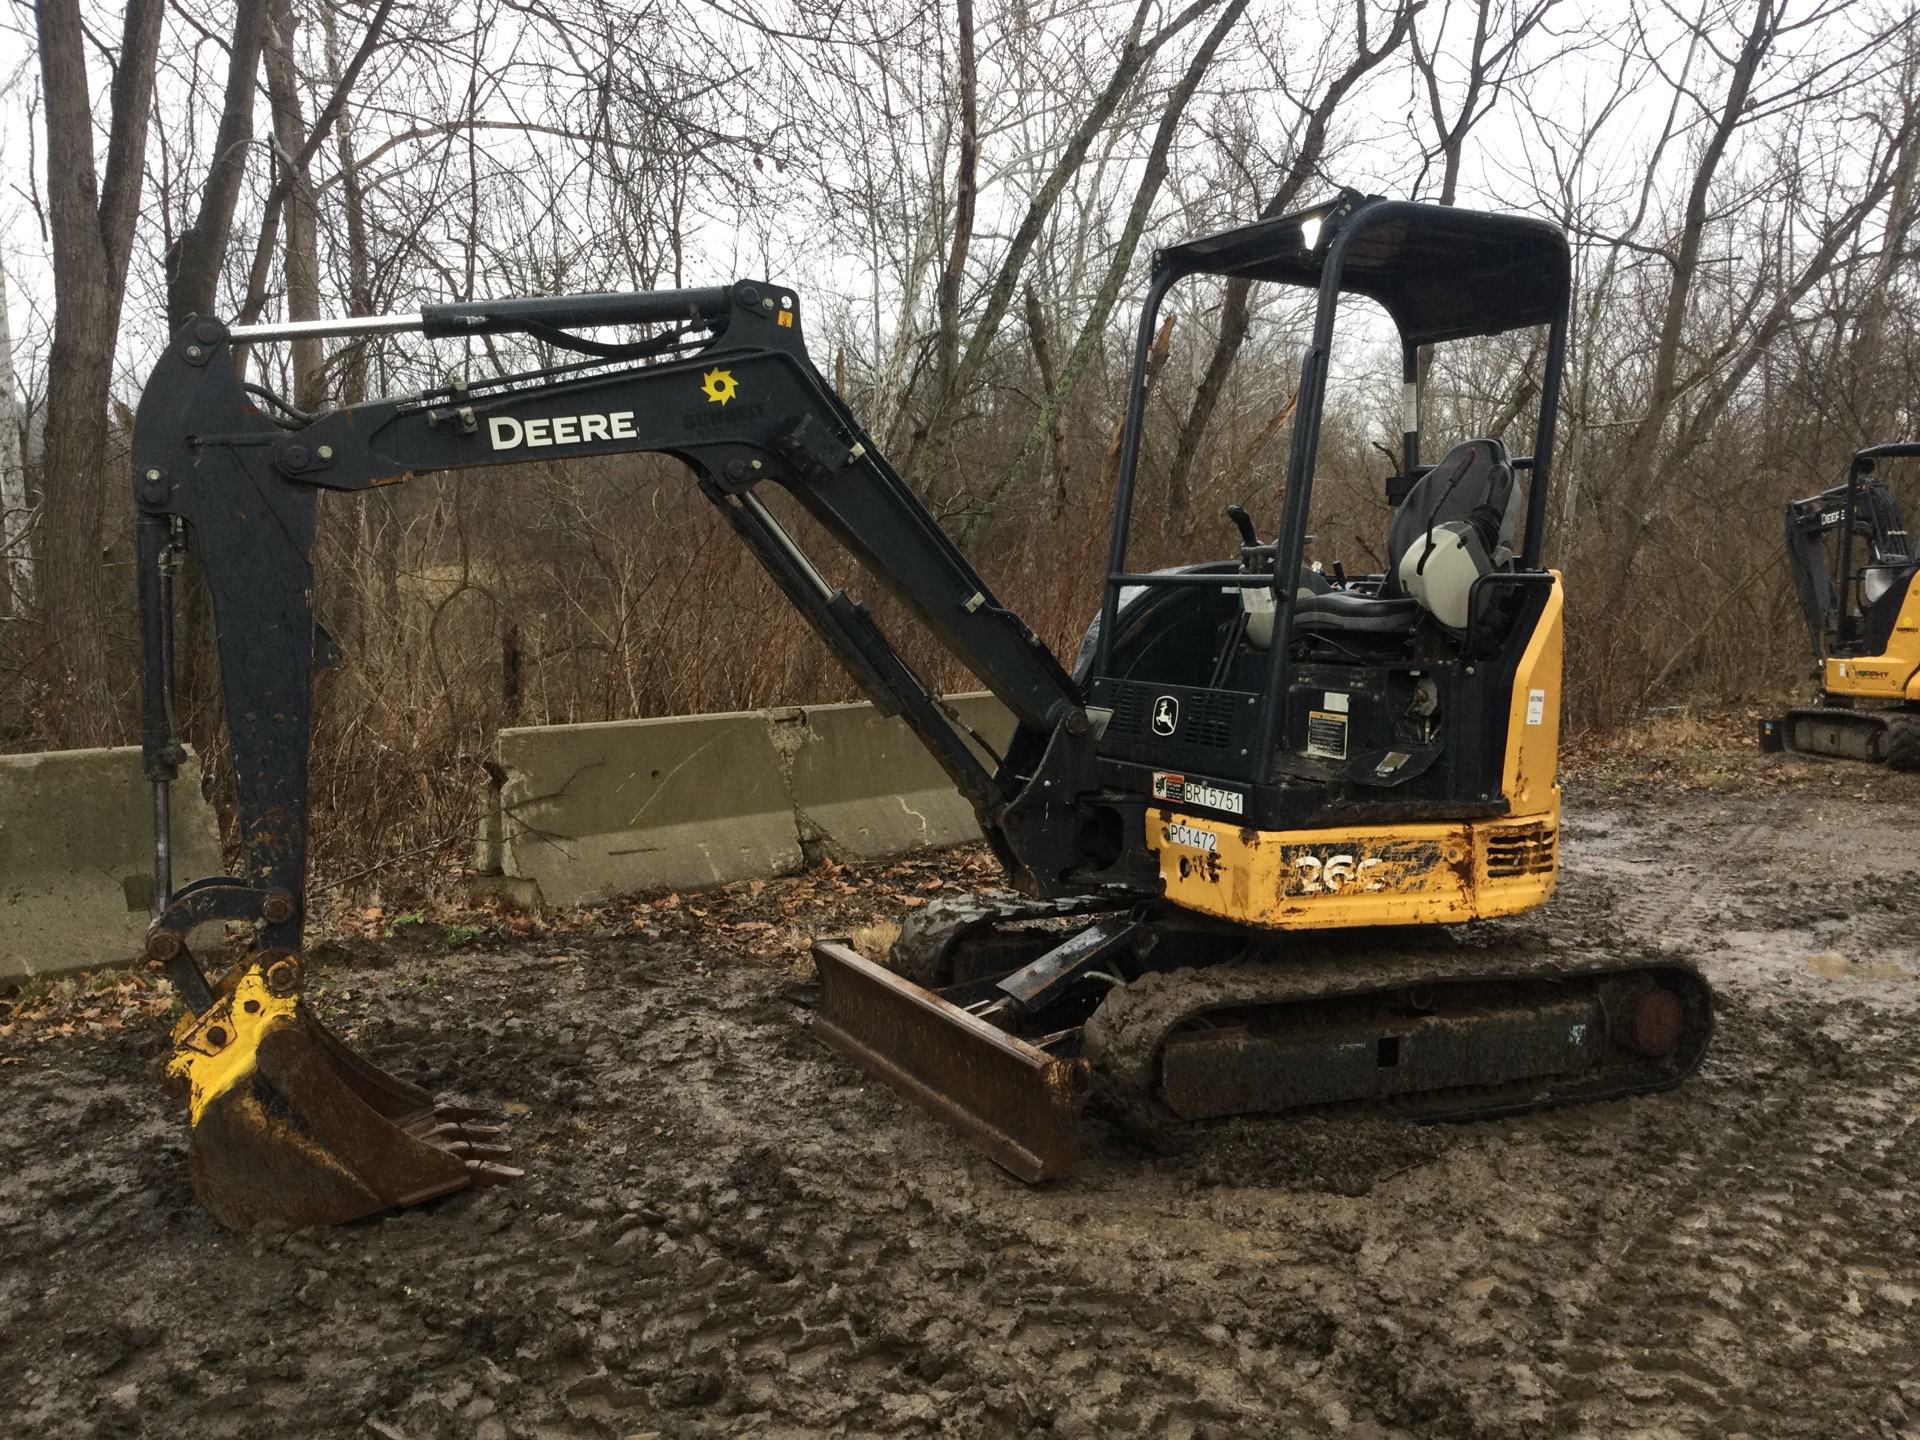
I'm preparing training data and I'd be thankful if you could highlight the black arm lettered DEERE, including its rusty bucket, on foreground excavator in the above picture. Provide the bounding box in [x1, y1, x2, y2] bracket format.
[132, 282, 1100, 1227]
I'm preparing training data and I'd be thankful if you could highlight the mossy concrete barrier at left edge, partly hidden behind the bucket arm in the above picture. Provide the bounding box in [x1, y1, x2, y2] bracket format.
[0, 745, 223, 983]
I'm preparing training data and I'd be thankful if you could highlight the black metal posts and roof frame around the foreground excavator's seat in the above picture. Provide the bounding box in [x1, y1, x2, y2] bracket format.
[1087, 190, 1572, 791]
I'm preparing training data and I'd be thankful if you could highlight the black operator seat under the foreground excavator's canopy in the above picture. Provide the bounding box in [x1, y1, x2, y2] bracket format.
[1294, 440, 1521, 636]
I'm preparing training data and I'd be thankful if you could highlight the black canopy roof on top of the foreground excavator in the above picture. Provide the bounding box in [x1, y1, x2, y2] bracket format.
[1156, 190, 1572, 346]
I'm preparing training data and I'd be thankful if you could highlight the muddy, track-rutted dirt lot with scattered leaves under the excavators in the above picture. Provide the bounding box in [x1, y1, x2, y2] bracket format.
[0, 751, 1920, 1440]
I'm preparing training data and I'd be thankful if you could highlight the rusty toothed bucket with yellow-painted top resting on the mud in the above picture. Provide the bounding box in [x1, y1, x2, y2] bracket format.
[167, 950, 520, 1231]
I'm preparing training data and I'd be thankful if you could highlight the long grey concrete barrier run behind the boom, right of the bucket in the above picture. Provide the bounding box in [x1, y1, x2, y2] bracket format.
[474, 695, 1014, 904]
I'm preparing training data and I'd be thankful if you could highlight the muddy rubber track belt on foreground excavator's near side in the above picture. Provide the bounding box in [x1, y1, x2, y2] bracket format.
[1081, 943, 1713, 1139]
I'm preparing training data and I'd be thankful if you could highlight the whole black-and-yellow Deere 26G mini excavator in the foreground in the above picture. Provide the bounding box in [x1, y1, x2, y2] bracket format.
[132, 190, 1713, 1227]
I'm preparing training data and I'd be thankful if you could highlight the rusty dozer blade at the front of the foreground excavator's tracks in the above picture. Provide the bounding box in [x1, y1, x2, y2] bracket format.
[814, 941, 1091, 1183]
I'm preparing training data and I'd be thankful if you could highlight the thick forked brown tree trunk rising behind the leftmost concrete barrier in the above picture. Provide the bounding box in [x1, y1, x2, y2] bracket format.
[36, 0, 165, 745]
